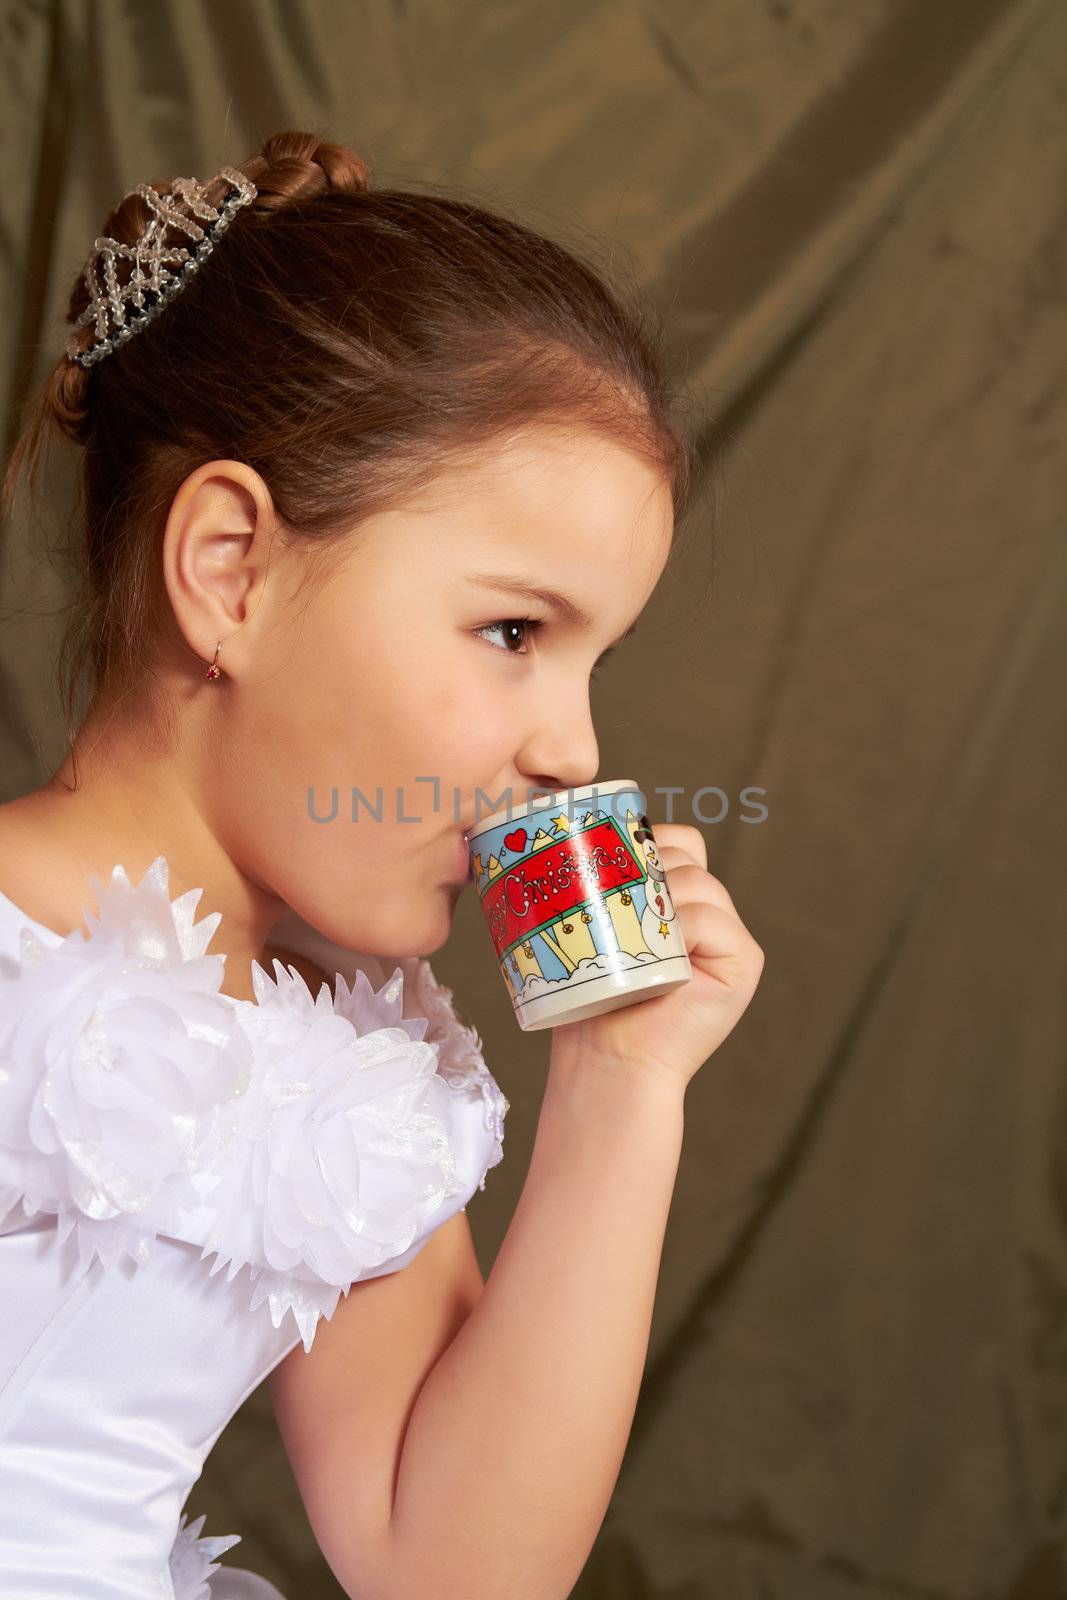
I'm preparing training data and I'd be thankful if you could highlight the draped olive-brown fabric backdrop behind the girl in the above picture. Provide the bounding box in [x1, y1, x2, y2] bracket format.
[0, 0, 1067, 1600]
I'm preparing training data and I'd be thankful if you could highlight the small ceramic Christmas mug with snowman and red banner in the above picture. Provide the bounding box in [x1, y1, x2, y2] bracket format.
[470, 778, 693, 1032]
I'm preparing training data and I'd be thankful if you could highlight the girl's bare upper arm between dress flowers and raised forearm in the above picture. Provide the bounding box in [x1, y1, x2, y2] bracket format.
[267, 1210, 485, 1594]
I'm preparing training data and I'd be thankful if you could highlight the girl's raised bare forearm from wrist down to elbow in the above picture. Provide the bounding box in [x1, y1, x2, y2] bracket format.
[384, 1046, 683, 1600]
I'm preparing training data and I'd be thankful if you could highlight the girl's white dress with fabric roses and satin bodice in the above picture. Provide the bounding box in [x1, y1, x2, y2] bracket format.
[0, 856, 509, 1600]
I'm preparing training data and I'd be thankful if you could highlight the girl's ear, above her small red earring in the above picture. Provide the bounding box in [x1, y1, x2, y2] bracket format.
[163, 461, 277, 677]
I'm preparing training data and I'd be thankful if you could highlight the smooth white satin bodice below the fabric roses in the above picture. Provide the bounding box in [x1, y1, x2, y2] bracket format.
[0, 1214, 299, 1600]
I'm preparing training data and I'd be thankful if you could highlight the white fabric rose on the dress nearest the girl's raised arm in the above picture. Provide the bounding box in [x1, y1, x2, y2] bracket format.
[191, 960, 502, 1347]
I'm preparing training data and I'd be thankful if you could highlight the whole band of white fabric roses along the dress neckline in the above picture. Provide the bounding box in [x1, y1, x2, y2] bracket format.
[0, 856, 509, 1349]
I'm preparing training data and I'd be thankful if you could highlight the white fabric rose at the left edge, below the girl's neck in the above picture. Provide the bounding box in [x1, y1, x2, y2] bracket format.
[0, 867, 253, 1267]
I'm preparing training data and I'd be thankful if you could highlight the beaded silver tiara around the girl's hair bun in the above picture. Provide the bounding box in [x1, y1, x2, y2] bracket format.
[67, 166, 256, 366]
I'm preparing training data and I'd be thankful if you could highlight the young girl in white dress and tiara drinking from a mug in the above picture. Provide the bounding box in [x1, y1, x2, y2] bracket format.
[0, 133, 763, 1600]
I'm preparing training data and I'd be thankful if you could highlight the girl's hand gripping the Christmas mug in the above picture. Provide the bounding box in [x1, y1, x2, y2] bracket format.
[552, 822, 763, 1088]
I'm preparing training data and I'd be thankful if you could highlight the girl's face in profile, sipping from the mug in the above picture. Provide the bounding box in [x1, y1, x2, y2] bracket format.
[175, 427, 673, 955]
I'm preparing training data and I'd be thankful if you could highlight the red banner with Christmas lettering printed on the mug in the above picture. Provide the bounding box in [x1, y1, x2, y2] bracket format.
[482, 821, 646, 955]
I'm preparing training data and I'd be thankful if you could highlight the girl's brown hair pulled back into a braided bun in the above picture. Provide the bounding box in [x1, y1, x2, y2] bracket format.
[0, 131, 697, 780]
